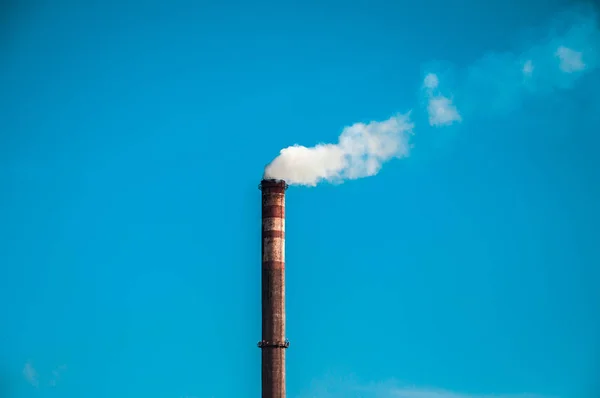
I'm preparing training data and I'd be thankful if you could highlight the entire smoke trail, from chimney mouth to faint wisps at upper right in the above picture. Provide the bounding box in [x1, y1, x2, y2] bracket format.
[264, 6, 600, 186]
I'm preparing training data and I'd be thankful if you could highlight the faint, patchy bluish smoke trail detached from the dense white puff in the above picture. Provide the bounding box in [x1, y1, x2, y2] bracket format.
[423, 2, 600, 123]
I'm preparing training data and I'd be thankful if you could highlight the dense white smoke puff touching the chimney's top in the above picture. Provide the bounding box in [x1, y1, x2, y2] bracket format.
[264, 112, 414, 186]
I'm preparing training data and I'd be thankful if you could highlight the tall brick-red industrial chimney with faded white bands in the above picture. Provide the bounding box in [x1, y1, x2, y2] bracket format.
[258, 179, 290, 398]
